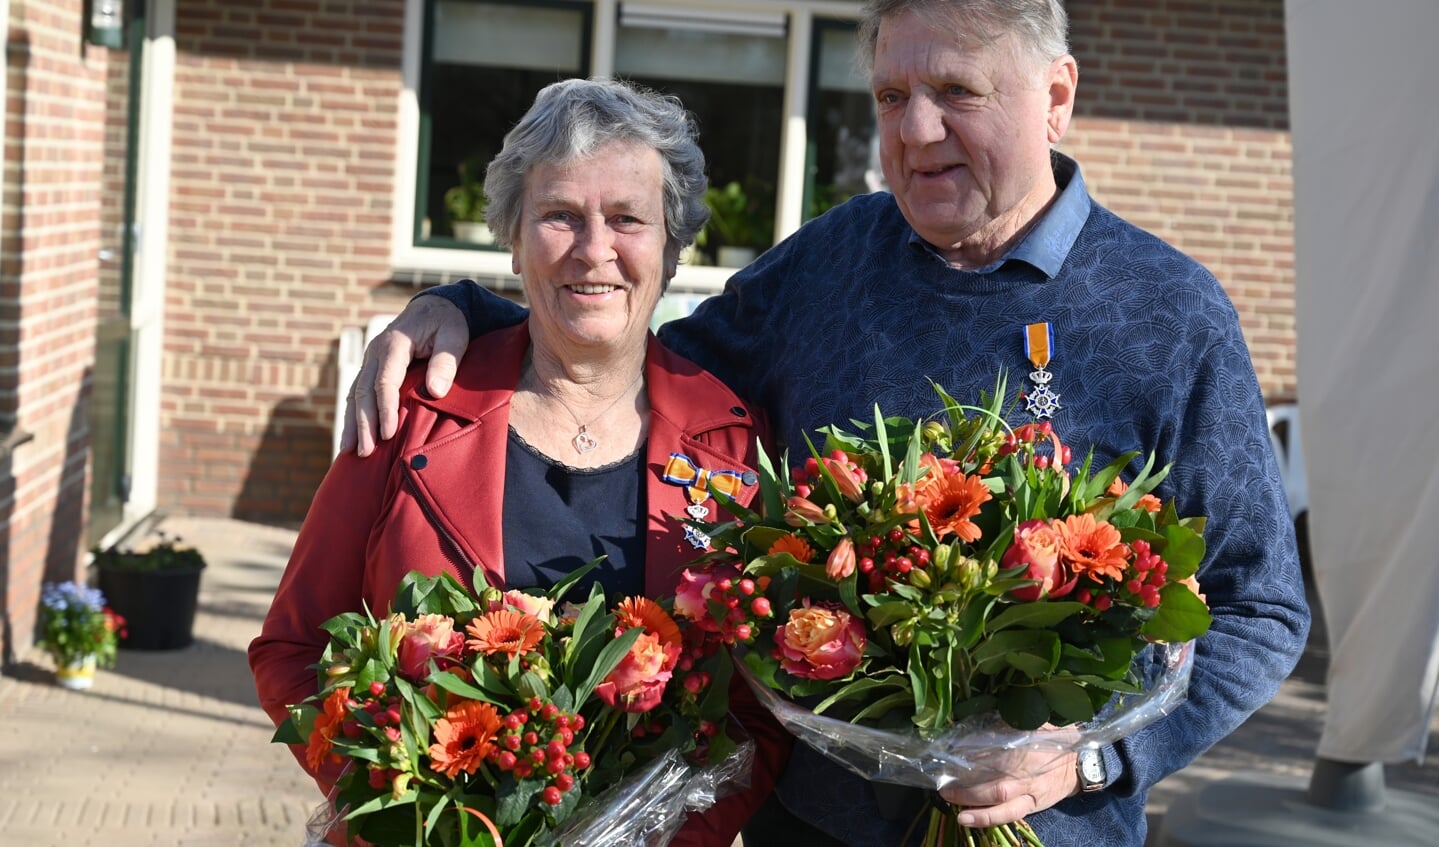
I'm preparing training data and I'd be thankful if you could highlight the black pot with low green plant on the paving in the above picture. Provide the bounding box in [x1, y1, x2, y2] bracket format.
[94, 532, 206, 650]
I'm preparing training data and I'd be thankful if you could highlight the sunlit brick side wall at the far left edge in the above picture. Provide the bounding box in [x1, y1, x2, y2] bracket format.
[0, 0, 108, 663]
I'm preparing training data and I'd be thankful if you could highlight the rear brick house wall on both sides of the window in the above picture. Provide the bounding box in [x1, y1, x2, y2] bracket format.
[160, 0, 1294, 522]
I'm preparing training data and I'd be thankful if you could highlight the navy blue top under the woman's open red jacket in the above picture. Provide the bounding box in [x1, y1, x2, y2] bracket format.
[502, 429, 646, 603]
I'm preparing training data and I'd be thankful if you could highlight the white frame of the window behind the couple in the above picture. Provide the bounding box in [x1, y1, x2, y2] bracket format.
[390, 0, 859, 293]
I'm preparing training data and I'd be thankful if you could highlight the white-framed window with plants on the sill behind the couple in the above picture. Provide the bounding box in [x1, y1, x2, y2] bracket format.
[391, 0, 878, 293]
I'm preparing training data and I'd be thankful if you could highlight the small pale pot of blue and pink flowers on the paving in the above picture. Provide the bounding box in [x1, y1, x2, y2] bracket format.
[39, 581, 125, 689]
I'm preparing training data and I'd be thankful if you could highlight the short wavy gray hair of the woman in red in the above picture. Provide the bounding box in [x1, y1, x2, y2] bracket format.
[485, 79, 709, 255]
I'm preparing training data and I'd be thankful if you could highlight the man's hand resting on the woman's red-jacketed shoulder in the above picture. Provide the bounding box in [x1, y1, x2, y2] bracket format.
[340, 296, 469, 456]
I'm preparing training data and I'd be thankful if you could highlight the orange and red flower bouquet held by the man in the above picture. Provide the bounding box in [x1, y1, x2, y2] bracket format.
[675, 377, 1210, 846]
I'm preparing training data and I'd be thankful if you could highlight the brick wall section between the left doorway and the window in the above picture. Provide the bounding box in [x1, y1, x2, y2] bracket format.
[160, 0, 404, 522]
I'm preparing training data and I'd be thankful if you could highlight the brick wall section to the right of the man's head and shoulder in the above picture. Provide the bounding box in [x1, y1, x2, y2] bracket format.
[1062, 0, 1295, 395]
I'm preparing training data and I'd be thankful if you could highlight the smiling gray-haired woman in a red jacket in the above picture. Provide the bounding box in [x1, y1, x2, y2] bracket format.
[249, 79, 789, 847]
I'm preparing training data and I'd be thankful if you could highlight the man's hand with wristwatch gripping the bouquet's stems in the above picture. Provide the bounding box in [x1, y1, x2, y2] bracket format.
[940, 733, 1079, 827]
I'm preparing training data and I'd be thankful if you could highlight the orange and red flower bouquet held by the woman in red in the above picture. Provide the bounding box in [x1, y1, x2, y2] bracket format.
[275, 562, 753, 847]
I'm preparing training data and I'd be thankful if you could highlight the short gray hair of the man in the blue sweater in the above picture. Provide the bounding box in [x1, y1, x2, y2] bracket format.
[858, 0, 1069, 75]
